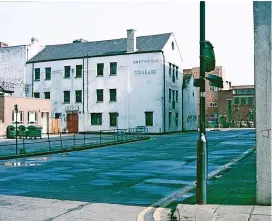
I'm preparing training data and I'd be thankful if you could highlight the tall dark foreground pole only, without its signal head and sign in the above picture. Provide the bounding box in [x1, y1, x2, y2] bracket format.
[196, 1, 208, 204]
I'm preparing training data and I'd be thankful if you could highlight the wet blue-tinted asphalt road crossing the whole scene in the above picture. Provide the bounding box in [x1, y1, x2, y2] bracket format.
[0, 130, 255, 206]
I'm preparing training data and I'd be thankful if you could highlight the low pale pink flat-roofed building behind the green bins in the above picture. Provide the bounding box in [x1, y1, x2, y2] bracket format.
[0, 94, 53, 135]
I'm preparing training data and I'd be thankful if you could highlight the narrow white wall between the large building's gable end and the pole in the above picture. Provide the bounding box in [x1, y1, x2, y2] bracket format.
[183, 77, 198, 131]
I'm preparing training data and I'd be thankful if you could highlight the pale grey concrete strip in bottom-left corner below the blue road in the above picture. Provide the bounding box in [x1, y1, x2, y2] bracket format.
[0, 195, 144, 221]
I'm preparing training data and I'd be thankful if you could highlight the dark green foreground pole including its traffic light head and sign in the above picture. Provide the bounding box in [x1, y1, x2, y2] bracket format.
[194, 1, 223, 204]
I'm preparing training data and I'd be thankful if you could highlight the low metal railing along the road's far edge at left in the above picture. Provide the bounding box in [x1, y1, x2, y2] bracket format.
[0, 128, 148, 157]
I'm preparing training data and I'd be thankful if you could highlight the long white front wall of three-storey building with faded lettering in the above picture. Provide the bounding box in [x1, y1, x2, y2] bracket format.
[27, 53, 166, 132]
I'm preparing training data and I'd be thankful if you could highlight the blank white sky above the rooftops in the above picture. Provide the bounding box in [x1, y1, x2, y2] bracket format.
[0, 0, 254, 85]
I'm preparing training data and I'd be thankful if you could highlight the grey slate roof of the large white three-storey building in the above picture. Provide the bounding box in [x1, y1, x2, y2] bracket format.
[27, 33, 172, 63]
